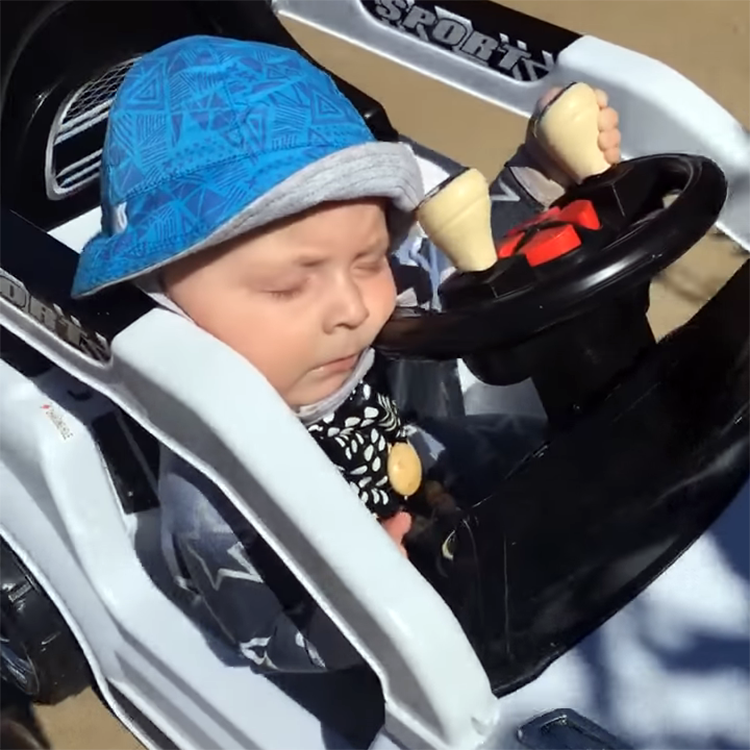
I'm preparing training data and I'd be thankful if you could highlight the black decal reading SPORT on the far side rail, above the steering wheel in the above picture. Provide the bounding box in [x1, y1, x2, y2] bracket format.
[362, 0, 576, 81]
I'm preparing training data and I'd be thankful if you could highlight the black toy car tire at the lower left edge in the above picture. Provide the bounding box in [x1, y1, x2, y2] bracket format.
[0, 540, 91, 704]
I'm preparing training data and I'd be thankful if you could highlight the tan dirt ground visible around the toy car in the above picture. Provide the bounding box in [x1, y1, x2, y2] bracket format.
[30, 0, 750, 750]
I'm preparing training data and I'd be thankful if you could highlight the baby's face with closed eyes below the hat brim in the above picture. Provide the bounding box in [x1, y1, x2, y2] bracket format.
[164, 200, 396, 407]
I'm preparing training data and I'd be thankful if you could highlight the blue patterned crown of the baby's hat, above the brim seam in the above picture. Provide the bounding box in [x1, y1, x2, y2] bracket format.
[102, 36, 372, 207]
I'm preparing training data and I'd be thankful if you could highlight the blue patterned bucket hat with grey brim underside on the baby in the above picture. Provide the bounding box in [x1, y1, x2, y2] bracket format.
[72, 36, 423, 297]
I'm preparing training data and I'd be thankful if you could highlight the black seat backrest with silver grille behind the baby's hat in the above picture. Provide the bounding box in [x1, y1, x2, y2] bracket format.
[0, 0, 395, 230]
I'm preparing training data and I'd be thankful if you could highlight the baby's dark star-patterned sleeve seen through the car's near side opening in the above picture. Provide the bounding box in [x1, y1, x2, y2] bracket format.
[159, 452, 361, 673]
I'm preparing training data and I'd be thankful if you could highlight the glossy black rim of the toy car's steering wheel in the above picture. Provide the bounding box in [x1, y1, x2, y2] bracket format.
[375, 154, 727, 359]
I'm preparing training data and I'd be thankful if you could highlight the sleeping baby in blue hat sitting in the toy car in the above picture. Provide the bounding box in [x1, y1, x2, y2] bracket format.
[73, 37, 619, 672]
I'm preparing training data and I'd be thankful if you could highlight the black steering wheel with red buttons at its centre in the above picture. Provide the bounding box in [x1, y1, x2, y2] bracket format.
[376, 154, 727, 422]
